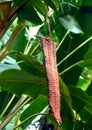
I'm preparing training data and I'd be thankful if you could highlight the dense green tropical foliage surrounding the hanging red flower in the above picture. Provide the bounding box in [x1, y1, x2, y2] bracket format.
[0, 0, 92, 130]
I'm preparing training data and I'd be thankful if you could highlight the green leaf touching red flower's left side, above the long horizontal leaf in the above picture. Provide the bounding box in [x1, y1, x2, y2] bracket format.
[16, 53, 45, 77]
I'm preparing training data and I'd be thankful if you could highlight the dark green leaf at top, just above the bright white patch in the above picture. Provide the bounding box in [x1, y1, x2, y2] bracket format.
[14, 0, 43, 25]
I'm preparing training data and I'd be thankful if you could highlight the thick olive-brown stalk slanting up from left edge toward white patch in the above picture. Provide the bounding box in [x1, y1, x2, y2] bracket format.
[0, 23, 25, 61]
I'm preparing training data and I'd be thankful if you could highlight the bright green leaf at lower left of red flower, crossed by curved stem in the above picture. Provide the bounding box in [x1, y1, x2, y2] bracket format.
[20, 96, 48, 127]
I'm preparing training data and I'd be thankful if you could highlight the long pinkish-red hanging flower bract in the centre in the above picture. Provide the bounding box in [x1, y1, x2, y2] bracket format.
[37, 36, 61, 124]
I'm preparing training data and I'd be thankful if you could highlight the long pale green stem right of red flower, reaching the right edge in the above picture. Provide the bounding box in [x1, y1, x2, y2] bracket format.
[57, 36, 92, 66]
